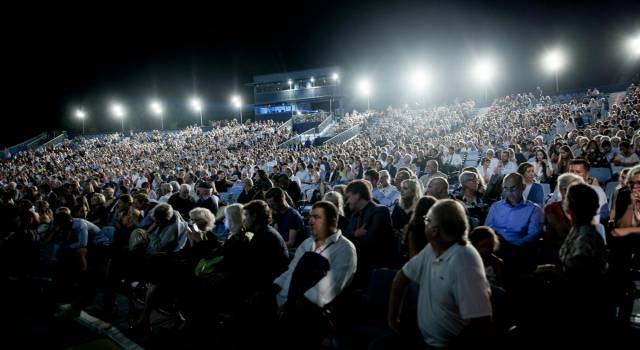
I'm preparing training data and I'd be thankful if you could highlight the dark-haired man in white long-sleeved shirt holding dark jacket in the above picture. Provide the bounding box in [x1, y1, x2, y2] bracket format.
[274, 201, 357, 348]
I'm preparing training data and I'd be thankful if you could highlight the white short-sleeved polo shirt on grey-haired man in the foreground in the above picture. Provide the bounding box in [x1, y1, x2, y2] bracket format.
[402, 243, 492, 347]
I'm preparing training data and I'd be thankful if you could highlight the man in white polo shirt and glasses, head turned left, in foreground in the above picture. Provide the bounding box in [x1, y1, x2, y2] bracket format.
[388, 199, 492, 348]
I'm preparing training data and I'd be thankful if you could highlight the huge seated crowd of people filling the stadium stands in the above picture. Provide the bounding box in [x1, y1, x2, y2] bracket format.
[0, 84, 640, 349]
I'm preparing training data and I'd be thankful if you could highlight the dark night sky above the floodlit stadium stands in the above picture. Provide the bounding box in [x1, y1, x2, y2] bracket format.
[0, 0, 640, 146]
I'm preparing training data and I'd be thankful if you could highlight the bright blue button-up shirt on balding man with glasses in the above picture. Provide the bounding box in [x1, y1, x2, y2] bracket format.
[485, 199, 543, 245]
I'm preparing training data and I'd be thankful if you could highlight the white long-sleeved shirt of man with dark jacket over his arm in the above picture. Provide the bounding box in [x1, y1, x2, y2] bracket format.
[273, 230, 357, 307]
